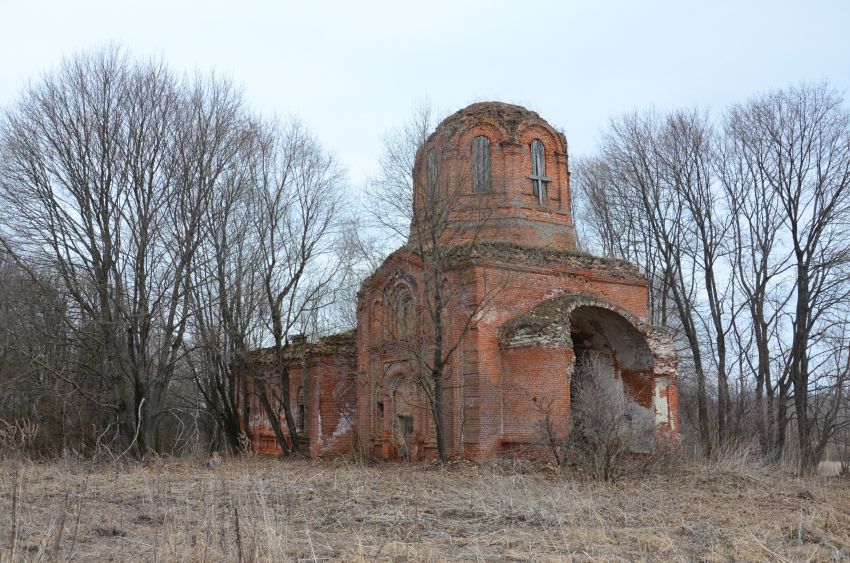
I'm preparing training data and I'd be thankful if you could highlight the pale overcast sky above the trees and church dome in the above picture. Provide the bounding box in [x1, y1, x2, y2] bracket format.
[0, 0, 850, 188]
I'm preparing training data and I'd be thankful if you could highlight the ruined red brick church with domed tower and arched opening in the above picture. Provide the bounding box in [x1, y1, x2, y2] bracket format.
[246, 102, 678, 460]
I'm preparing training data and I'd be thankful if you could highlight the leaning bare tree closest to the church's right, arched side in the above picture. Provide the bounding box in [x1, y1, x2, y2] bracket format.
[588, 113, 713, 453]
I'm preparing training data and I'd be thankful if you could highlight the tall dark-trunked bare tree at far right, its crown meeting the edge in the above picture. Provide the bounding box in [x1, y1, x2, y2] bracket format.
[747, 84, 850, 473]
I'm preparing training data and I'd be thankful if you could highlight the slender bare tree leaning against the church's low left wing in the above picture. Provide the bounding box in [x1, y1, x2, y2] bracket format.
[251, 122, 345, 452]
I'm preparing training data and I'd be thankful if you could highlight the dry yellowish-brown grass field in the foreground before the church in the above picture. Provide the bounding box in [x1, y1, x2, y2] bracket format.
[0, 459, 850, 561]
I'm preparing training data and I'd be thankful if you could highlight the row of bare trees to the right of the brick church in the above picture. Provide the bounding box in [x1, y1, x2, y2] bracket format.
[575, 83, 850, 472]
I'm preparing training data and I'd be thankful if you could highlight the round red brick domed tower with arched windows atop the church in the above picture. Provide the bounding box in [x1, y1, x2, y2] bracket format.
[411, 102, 575, 250]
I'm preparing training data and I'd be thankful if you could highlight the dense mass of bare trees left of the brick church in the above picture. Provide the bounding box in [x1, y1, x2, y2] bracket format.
[0, 47, 350, 457]
